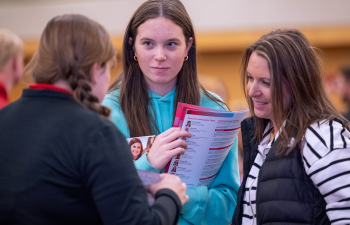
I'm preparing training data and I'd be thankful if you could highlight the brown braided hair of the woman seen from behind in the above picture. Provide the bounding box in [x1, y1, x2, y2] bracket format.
[25, 14, 115, 117]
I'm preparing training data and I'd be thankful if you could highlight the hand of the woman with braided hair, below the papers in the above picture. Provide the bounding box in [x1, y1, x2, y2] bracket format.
[146, 173, 188, 205]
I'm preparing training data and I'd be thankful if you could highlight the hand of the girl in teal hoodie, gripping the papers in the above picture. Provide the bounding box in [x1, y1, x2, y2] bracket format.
[147, 127, 192, 170]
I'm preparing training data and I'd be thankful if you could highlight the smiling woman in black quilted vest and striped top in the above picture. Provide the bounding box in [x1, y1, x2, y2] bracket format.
[232, 29, 350, 224]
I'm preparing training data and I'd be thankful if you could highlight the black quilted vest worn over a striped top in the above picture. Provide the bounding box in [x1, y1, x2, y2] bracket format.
[232, 117, 330, 225]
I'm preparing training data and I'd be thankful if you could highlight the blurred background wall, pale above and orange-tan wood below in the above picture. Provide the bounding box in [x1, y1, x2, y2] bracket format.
[0, 0, 350, 110]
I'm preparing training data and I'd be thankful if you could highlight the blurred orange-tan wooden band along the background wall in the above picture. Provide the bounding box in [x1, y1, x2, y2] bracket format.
[10, 27, 350, 110]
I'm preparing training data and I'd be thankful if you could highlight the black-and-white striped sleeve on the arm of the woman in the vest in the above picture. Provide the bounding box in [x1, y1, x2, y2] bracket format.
[303, 120, 350, 225]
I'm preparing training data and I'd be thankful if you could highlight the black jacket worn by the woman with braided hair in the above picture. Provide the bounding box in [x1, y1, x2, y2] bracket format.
[0, 89, 181, 225]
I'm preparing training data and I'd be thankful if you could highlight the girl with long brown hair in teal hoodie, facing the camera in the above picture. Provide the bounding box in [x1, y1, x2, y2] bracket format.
[103, 0, 239, 224]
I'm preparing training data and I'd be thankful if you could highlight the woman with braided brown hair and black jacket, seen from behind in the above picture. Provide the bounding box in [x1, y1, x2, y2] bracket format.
[0, 15, 188, 225]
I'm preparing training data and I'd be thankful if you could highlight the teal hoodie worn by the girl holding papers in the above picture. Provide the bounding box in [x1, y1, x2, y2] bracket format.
[102, 88, 239, 225]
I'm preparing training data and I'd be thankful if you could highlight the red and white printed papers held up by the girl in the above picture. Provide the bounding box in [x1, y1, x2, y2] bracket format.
[165, 103, 248, 188]
